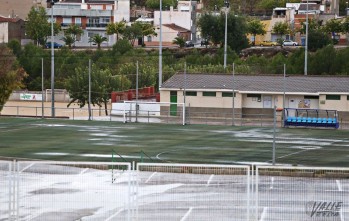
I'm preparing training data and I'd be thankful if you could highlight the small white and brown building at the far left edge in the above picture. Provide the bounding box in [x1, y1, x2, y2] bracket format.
[0, 16, 25, 43]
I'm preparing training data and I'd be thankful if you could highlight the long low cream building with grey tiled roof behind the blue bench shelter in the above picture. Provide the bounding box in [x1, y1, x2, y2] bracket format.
[160, 73, 349, 120]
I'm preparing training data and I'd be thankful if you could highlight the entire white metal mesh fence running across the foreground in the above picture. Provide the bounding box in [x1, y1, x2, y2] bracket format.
[0, 161, 349, 221]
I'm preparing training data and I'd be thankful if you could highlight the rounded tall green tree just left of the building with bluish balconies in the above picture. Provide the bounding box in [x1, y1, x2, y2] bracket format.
[25, 7, 60, 45]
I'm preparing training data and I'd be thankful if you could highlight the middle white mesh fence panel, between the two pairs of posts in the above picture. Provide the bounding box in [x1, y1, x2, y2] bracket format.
[136, 163, 250, 221]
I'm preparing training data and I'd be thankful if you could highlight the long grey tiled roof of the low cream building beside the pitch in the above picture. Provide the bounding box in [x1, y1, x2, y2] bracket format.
[161, 73, 349, 94]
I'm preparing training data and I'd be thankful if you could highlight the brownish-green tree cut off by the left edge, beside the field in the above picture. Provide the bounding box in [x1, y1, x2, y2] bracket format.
[0, 44, 26, 111]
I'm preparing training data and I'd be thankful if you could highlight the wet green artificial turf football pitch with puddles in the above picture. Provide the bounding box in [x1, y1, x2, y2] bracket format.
[0, 117, 349, 167]
